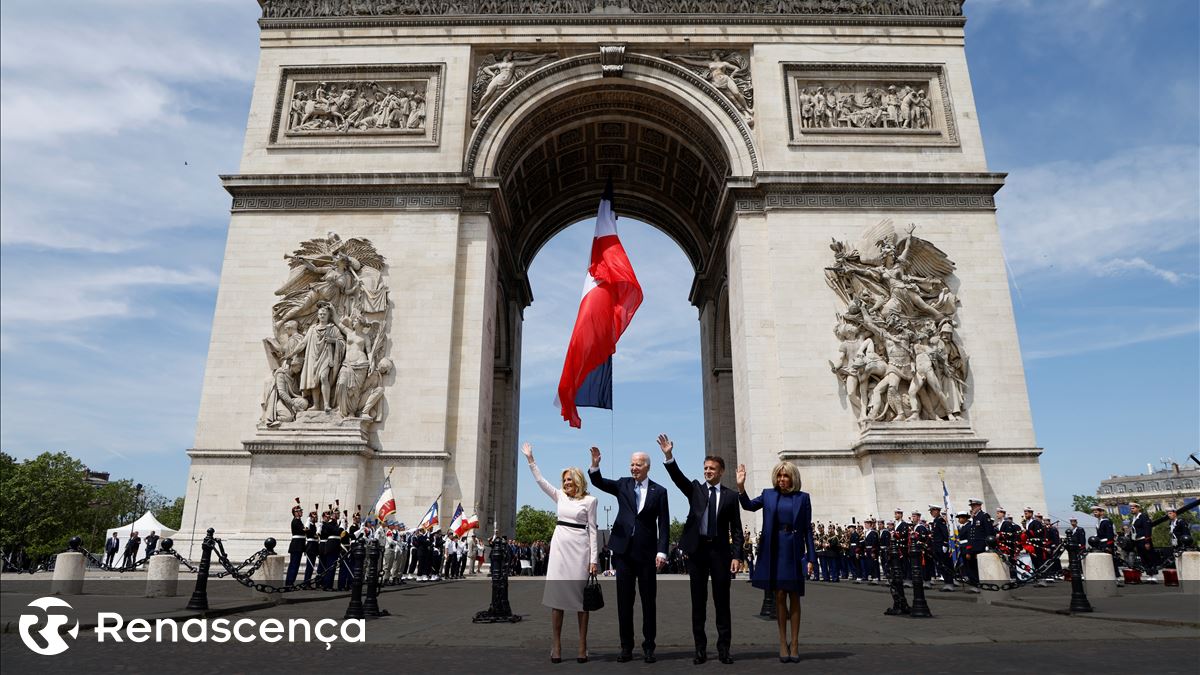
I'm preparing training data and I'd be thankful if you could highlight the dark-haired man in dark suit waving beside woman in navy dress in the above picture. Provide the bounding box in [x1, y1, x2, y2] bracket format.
[659, 434, 745, 665]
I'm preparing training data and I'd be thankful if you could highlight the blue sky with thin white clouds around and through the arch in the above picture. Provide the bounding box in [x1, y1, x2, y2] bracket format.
[0, 0, 1200, 526]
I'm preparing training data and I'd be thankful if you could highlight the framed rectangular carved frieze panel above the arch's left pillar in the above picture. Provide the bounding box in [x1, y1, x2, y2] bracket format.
[271, 64, 445, 148]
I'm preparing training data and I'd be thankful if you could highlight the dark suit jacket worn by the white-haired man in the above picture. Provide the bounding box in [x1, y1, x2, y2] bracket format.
[588, 468, 671, 561]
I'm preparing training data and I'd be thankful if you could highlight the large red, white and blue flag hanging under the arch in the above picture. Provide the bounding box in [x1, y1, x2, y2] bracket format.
[554, 178, 642, 429]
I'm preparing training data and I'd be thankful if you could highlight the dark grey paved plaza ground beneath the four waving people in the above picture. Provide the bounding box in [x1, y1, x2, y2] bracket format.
[0, 575, 1200, 673]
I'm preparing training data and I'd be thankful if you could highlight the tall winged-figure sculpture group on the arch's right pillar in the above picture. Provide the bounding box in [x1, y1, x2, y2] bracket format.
[826, 220, 967, 425]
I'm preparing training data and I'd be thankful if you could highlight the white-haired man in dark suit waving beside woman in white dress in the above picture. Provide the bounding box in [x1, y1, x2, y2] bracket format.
[588, 447, 671, 663]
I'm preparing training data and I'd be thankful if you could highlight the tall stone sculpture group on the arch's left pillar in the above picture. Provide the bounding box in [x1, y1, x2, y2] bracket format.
[259, 232, 391, 429]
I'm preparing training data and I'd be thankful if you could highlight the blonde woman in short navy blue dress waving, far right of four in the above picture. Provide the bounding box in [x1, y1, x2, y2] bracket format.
[737, 461, 815, 663]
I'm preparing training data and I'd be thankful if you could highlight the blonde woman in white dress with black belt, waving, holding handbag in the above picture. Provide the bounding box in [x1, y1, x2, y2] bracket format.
[521, 443, 599, 663]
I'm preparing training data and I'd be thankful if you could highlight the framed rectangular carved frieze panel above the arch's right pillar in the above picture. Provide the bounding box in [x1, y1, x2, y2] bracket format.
[784, 62, 959, 147]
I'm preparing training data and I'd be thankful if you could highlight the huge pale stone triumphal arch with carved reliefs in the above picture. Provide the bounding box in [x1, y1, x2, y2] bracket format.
[181, 0, 1045, 550]
